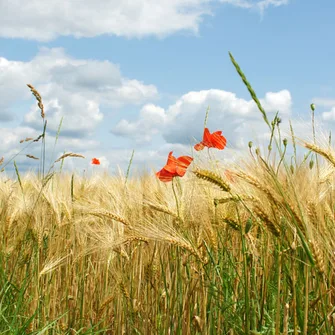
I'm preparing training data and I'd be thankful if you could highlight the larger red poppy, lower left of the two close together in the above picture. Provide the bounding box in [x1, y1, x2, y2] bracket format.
[156, 151, 193, 182]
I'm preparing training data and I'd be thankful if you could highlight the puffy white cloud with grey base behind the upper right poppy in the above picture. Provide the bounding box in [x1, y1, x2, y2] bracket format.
[112, 89, 292, 148]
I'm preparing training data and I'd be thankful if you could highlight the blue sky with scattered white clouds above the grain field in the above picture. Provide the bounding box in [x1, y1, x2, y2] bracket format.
[0, 0, 335, 178]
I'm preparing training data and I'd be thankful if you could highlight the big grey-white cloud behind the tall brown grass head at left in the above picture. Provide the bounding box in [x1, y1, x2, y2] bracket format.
[0, 48, 157, 137]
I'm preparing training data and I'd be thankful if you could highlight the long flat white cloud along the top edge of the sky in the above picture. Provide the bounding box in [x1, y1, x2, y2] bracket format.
[0, 0, 288, 41]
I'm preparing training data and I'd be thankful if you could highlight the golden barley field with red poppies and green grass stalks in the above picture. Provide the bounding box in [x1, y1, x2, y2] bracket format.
[0, 55, 335, 335]
